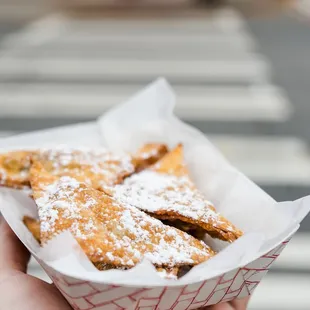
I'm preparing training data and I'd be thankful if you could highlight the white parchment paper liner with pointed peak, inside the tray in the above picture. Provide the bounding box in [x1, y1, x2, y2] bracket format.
[0, 79, 310, 287]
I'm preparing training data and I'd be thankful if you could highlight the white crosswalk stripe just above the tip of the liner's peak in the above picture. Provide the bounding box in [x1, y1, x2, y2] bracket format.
[0, 57, 268, 83]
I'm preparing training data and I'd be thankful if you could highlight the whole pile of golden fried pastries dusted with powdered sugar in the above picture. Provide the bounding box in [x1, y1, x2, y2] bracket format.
[0, 144, 242, 278]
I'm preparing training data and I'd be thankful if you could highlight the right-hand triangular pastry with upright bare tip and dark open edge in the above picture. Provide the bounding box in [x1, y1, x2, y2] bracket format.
[105, 145, 242, 242]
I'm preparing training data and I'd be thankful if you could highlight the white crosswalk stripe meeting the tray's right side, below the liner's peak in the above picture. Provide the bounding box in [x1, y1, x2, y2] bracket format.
[210, 135, 310, 186]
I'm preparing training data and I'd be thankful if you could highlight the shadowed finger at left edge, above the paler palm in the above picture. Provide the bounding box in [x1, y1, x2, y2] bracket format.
[0, 215, 30, 272]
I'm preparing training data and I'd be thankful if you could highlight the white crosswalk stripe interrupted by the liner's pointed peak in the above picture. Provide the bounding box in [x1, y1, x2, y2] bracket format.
[0, 83, 292, 122]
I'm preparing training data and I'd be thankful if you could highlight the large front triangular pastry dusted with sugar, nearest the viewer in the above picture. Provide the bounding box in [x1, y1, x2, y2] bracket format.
[30, 161, 214, 268]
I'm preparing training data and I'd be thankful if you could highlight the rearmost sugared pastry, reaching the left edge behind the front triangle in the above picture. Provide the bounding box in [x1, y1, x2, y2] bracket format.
[0, 144, 167, 190]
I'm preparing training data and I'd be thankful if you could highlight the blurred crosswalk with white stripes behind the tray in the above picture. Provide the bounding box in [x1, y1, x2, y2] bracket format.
[0, 9, 310, 310]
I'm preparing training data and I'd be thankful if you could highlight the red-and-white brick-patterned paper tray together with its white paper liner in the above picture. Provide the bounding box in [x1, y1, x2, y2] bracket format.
[0, 79, 310, 310]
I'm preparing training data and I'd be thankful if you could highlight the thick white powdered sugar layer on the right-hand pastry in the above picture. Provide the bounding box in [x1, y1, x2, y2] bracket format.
[109, 170, 218, 222]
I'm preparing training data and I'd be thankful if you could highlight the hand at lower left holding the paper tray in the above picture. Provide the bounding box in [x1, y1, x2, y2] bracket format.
[0, 215, 72, 310]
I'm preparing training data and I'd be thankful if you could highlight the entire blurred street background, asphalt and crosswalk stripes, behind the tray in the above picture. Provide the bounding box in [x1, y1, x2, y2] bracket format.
[0, 0, 310, 310]
